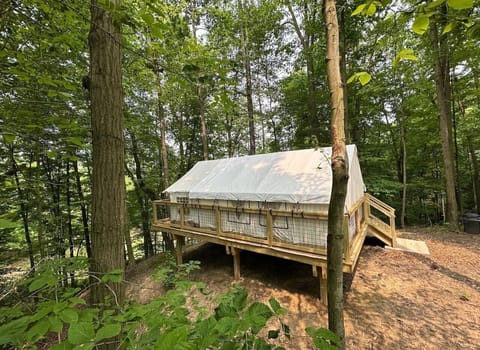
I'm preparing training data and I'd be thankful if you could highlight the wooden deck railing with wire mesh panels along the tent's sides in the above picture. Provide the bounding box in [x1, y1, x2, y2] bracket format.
[153, 197, 368, 261]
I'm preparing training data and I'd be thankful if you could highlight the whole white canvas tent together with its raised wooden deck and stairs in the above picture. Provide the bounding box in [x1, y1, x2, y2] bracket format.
[152, 145, 396, 303]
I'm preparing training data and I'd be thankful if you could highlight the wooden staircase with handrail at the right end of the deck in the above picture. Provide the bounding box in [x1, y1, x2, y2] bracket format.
[366, 193, 397, 247]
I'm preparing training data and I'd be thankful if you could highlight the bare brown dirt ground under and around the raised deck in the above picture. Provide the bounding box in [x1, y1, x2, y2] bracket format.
[128, 229, 480, 350]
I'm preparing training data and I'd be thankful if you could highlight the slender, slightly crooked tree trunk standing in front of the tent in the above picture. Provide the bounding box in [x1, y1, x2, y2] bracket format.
[324, 0, 348, 349]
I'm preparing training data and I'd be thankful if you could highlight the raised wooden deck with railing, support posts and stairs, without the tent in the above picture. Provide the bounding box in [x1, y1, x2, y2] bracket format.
[152, 194, 396, 303]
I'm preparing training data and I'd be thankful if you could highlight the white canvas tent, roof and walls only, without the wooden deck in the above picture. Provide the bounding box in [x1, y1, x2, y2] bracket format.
[165, 145, 365, 247]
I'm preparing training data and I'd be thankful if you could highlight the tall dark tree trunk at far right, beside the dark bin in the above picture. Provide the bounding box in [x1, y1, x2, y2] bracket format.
[430, 4, 458, 229]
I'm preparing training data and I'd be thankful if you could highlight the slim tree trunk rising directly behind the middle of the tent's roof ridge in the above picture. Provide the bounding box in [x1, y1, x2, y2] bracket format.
[238, 0, 256, 154]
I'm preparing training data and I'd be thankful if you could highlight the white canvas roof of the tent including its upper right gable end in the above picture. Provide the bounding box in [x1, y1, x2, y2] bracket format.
[165, 145, 365, 208]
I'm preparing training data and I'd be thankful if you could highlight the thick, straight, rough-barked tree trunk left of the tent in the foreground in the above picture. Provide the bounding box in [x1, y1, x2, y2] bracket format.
[89, 0, 126, 318]
